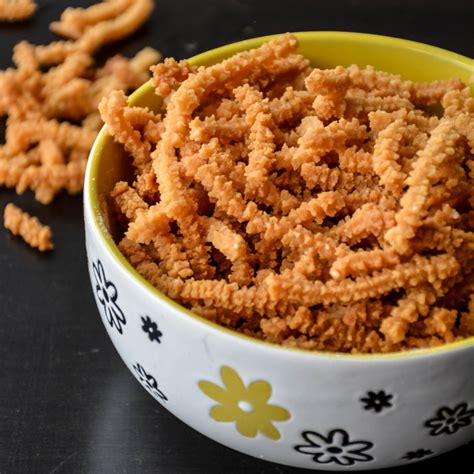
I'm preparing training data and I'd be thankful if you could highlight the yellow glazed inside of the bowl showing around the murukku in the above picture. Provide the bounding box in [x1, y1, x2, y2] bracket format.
[88, 31, 474, 357]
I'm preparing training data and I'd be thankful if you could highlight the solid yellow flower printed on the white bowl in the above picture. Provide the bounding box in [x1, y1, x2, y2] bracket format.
[199, 366, 290, 440]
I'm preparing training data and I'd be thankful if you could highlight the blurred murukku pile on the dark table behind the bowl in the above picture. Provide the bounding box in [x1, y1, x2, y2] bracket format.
[0, 0, 160, 250]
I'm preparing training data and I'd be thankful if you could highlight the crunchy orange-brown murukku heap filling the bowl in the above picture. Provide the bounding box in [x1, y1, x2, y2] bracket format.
[99, 34, 474, 353]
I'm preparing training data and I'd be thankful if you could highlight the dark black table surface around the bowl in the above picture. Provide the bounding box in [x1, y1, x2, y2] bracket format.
[0, 0, 474, 474]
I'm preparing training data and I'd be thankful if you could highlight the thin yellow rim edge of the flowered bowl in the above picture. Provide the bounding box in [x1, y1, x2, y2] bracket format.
[84, 31, 474, 361]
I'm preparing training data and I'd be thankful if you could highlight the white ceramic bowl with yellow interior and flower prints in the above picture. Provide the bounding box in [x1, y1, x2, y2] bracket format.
[84, 32, 474, 470]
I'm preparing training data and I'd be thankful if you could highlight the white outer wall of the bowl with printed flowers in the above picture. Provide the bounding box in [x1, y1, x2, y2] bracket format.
[85, 206, 474, 470]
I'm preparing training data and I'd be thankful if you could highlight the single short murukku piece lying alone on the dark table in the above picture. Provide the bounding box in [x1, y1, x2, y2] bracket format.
[3, 203, 54, 252]
